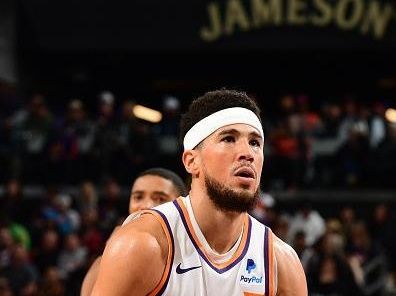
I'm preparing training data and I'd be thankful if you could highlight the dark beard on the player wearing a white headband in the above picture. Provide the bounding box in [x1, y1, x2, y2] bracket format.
[205, 175, 260, 213]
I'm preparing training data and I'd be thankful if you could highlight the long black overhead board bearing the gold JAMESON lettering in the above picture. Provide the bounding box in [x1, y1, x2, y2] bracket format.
[18, 0, 396, 52]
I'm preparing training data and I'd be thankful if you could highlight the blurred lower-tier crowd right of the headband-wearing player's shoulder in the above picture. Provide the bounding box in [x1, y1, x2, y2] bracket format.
[252, 194, 396, 296]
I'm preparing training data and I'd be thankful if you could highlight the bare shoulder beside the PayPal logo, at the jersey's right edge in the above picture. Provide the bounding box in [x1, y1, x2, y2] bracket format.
[273, 234, 308, 296]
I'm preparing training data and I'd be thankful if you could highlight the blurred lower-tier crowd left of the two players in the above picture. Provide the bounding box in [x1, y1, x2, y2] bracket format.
[0, 179, 129, 296]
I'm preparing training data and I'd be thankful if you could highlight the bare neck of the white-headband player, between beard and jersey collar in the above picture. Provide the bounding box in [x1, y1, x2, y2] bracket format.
[190, 184, 246, 254]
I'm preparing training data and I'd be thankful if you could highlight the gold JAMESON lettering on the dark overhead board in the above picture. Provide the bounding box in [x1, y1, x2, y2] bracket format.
[203, 0, 396, 42]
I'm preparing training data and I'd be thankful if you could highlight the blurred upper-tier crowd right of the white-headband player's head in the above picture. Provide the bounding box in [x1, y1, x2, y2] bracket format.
[264, 95, 396, 189]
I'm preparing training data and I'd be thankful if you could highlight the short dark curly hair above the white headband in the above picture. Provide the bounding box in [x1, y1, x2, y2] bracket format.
[180, 88, 261, 143]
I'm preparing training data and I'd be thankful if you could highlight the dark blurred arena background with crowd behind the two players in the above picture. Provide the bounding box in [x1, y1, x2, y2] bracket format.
[0, 0, 396, 295]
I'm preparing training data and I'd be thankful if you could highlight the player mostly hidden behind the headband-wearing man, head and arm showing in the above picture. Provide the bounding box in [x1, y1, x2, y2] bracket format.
[81, 168, 187, 296]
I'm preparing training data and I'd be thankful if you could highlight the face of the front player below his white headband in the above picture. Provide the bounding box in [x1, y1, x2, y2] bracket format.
[201, 124, 264, 196]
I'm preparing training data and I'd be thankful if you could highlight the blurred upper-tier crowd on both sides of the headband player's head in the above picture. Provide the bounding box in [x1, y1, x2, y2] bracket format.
[0, 91, 396, 190]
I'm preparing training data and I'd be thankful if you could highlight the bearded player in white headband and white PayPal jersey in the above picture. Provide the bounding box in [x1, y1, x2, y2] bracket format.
[92, 90, 308, 296]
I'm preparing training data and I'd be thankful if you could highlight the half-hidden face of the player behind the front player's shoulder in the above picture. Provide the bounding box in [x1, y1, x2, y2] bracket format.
[129, 175, 178, 214]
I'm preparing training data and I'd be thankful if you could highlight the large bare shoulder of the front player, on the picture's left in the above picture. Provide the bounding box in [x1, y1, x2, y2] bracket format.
[93, 215, 168, 295]
